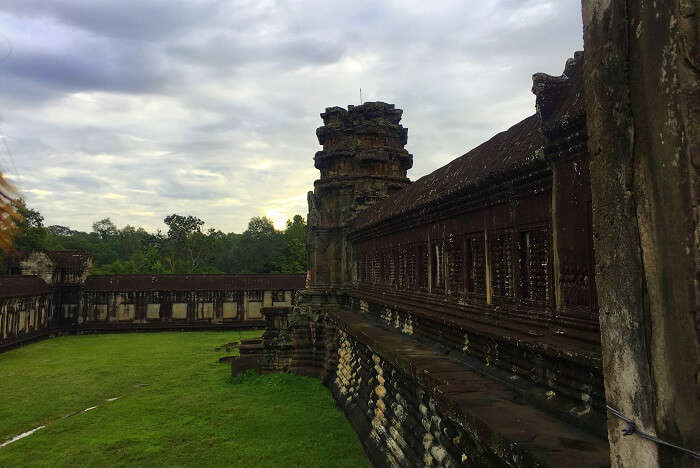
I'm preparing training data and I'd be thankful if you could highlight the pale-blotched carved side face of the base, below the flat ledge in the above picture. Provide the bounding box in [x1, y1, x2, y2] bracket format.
[331, 330, 502, 467]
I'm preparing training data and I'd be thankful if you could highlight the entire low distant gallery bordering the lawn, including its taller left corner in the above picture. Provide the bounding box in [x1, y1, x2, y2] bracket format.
[0, 252, 305, 351]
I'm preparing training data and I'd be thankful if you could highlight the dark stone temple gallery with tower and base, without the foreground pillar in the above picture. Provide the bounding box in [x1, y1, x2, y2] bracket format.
[242, 53, 608, 466]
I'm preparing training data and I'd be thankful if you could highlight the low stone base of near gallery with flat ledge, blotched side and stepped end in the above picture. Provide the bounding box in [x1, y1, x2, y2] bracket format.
[232, 302, 609, 468]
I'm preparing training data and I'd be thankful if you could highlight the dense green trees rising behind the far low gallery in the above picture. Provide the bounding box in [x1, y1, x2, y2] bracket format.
[0, 199, 307, 275]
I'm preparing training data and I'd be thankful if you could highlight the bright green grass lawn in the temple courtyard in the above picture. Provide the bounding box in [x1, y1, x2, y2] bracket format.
[0, 331, 369, 467]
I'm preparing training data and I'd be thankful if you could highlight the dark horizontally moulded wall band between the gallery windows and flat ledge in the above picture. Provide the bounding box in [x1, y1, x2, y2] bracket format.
[345, 294, 606, 436]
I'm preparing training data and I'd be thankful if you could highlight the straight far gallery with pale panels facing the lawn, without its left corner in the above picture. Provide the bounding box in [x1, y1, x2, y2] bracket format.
[82, 274, 304, 327]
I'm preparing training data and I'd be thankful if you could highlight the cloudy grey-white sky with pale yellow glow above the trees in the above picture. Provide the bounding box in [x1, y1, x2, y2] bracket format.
[0, 0, 583, 232]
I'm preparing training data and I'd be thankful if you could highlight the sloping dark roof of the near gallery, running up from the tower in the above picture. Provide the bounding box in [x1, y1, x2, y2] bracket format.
[353, 114, 545, 229]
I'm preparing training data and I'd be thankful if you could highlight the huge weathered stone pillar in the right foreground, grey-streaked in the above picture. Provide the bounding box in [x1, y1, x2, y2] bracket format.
[583, 0, 700, 467]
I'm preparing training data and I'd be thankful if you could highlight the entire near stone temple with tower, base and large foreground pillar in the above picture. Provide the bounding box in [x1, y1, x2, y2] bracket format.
[237, 7, 700, 460]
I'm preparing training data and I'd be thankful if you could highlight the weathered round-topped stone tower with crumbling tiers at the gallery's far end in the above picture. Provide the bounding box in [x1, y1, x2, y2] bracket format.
[308, 102, 413, 289]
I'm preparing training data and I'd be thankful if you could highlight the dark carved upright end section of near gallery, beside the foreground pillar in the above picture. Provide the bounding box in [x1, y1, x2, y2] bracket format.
[532, 52, 598, 324]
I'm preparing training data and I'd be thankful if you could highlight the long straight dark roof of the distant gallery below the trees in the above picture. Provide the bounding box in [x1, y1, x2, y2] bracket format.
[85, 273, 306, 292]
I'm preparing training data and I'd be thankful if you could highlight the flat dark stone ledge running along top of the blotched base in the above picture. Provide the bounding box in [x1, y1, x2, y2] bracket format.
[333, 310, 610, 468]
